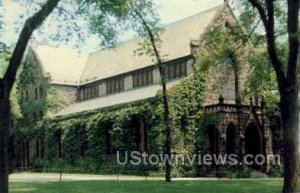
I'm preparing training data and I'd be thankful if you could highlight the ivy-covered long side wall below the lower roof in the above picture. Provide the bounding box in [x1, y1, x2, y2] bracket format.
[26, 70, 205, 176]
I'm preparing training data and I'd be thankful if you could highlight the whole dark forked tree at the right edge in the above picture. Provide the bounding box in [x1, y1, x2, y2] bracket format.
[239, 0, 300, 193]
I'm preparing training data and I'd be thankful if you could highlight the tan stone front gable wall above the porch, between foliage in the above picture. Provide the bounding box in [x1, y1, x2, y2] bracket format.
[197, 3, 251, 105]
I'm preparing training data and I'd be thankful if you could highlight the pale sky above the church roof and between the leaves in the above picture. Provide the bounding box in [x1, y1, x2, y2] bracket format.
[0, 0, 224, 52]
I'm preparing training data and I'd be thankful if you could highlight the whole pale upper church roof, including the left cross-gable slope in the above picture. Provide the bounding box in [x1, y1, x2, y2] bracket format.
[32, 4, 225, 85]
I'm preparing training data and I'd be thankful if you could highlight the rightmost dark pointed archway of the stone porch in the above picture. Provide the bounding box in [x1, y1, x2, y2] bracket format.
[245, 123, 263, 170]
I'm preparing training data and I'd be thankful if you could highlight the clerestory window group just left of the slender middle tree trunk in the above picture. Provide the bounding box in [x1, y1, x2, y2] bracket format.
[132, 69, 153, 88]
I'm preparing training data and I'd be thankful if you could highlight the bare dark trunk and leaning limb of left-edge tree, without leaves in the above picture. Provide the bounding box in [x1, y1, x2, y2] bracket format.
[0, 0, 59, 193]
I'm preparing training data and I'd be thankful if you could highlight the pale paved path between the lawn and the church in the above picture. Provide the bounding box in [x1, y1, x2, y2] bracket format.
[9, 172, 282, 182]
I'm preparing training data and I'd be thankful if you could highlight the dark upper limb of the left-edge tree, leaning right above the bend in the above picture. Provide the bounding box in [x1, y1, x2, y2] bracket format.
[3, 0, 60, 92]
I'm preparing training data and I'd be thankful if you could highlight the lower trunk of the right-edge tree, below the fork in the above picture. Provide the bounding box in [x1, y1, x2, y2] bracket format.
[281, 85, 299, 193]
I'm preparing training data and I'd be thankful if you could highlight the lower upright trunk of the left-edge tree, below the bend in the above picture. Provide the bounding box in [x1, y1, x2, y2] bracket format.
[0, 97, 10, 193]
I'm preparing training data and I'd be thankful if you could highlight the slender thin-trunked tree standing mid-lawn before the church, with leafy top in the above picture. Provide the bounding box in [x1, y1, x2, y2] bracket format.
[84, 0, 171, 182]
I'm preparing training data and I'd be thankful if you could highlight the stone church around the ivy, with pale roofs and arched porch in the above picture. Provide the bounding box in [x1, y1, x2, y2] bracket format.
[20, 3, 272, 173]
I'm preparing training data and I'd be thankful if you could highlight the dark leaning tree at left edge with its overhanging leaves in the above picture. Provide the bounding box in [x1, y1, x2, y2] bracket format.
[0, 0, 150, 193]
